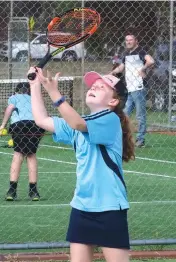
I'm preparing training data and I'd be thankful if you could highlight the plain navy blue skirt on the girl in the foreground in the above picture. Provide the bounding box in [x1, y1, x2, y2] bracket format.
[66, 208, 130, 249]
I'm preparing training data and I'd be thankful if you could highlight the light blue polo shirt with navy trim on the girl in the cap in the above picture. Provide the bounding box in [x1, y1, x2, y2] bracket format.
[53, 109, 129, 212]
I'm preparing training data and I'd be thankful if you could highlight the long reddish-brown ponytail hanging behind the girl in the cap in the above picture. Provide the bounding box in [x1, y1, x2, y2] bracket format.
[113, 92, 135, 162]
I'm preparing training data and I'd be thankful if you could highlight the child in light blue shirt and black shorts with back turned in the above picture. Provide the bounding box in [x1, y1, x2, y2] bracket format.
[0, 82, 44, 201]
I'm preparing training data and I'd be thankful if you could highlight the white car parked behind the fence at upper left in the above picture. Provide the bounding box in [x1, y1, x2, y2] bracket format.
[0, 34, 86, 62]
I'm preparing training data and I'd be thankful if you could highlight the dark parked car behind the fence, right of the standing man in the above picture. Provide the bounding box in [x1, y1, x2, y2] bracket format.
[148, 41, 176, 111]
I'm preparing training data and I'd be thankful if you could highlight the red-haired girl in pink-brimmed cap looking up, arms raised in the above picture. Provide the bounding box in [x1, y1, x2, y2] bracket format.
[28, 67, 134, 262]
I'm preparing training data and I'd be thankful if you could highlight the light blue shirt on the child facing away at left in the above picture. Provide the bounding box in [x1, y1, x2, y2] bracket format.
[8, 94, 34, 124]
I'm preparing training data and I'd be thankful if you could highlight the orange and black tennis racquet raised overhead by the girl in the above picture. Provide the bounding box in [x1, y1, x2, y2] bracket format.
[28, 8, 101, 80]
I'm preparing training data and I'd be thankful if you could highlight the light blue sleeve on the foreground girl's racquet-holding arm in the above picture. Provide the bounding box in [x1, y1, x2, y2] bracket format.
[52, 117, 74, 144]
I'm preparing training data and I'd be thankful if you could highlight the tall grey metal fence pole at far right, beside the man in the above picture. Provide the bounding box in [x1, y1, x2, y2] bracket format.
[168, 0, 174, 126]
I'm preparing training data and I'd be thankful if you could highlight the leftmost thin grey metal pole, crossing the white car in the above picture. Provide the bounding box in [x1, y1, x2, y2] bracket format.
[8, 0, 13, 79]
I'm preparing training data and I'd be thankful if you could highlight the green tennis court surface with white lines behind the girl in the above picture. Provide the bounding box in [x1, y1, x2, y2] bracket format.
[0, 133, 176, 243]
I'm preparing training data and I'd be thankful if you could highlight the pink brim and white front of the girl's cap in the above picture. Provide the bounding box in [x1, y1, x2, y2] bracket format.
[84, 71, 120, 89]
